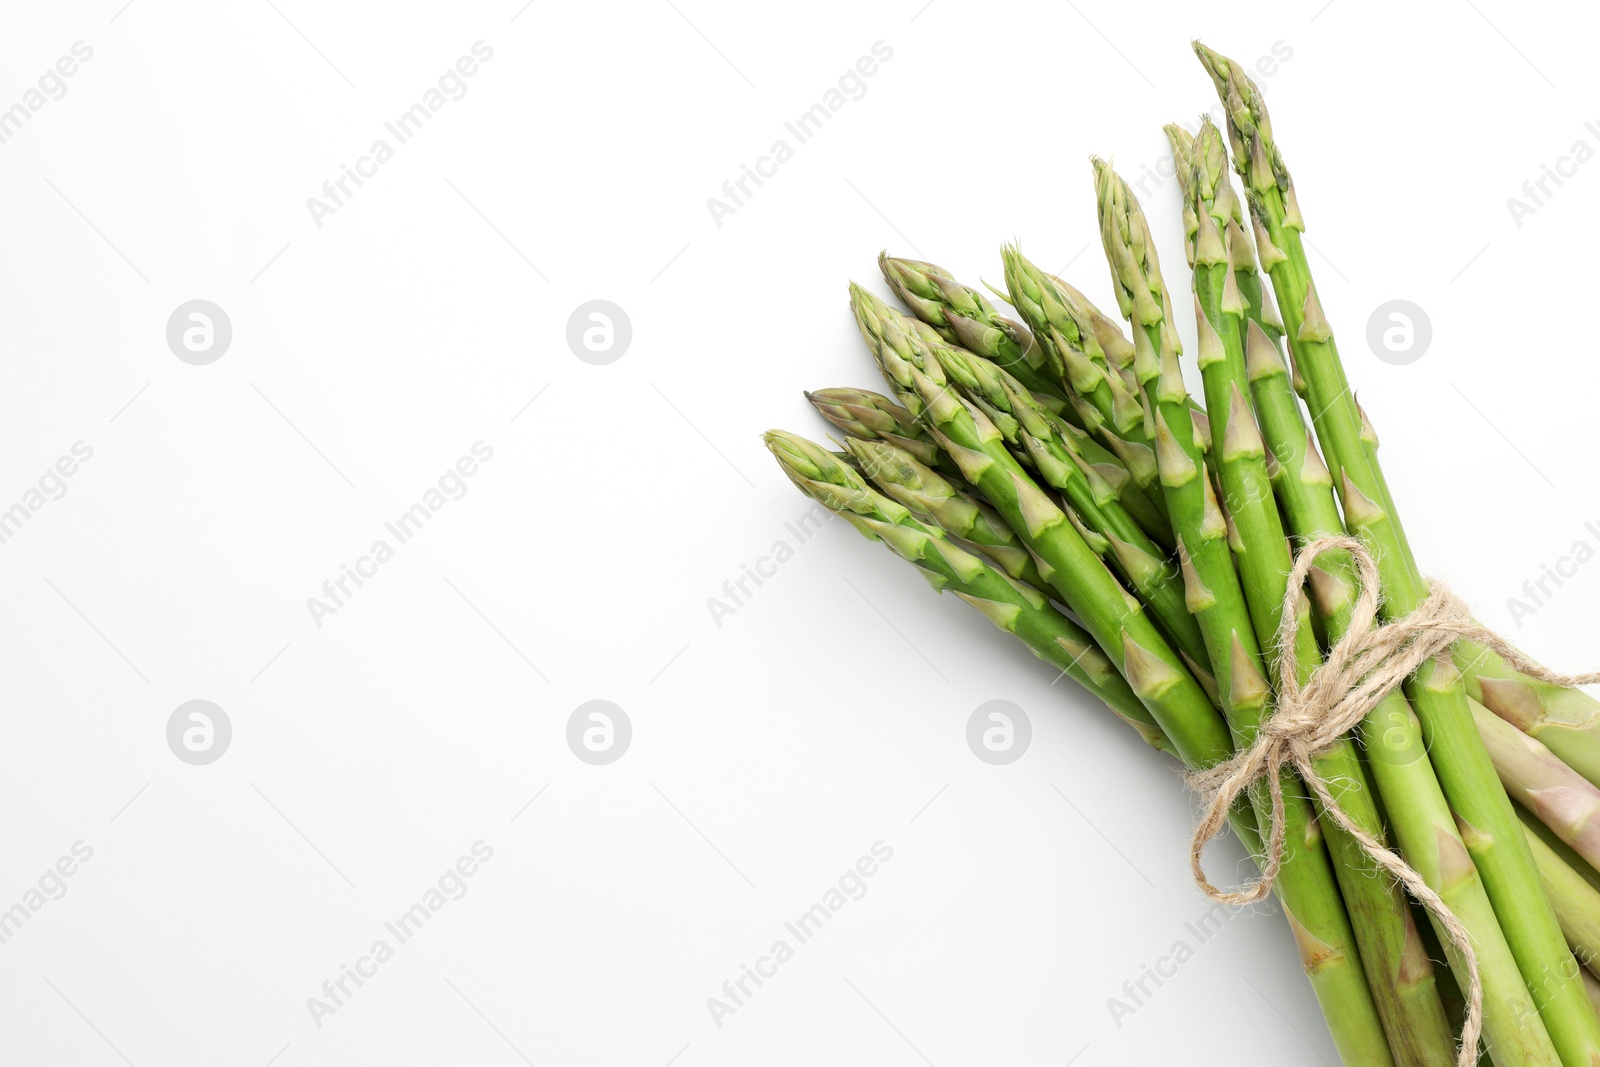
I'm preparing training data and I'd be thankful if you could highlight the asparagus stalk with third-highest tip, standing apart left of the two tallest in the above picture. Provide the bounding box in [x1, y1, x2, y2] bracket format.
[1094, 160, 1392, 1064]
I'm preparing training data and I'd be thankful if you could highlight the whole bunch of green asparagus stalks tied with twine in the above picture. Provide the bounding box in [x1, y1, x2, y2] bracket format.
[766, 43, 1600, 1067]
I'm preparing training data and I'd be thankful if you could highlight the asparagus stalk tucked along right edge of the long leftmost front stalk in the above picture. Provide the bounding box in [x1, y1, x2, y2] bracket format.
[930, 329, 1210, 683]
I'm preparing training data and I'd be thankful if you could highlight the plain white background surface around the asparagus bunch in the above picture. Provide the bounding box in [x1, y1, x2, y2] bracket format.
[0, 0, 1600, 1067]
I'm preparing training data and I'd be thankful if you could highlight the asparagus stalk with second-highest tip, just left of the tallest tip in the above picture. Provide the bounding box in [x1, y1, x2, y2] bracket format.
[1174, 120, 1456, 1067]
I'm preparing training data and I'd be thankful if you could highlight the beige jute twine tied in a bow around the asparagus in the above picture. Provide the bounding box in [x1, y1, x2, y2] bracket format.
[1189, 536, 1600, 1067]
